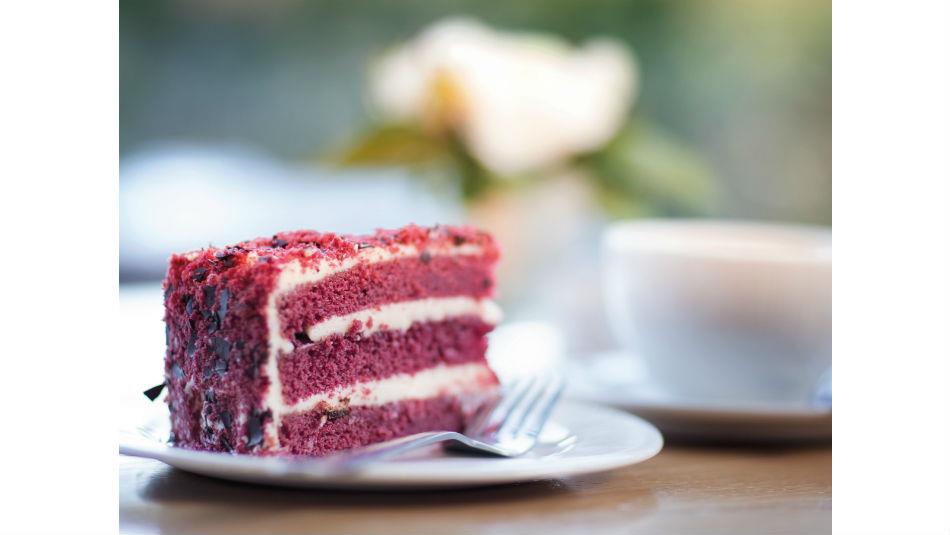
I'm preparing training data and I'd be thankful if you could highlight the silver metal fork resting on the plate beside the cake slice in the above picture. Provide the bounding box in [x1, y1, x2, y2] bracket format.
[324, 376, 564, 472]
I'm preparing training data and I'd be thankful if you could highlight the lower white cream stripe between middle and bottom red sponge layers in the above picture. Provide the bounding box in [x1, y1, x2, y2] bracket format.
[284, 362, 494, 414]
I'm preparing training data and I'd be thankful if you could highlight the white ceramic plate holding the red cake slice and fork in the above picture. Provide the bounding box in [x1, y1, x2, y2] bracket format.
[119, 402, 663, 489]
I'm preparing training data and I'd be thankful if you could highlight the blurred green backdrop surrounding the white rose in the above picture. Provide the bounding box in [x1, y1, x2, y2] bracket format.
[120, 0, 831, 223]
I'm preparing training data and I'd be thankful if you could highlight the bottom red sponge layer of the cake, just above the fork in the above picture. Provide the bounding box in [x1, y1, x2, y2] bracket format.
[279, 391, 497, 455]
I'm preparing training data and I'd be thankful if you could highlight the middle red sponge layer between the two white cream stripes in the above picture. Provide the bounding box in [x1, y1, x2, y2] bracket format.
[277, 316, 493, 404]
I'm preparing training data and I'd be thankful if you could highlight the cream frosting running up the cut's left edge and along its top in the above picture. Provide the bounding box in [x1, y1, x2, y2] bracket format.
[264, 244, 494, 446]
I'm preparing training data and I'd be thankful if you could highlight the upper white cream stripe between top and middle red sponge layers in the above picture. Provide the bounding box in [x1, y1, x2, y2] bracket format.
[307, 297, 501, 342]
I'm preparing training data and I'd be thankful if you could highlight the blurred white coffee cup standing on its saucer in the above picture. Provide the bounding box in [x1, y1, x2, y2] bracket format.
[602, 220, 831, 403]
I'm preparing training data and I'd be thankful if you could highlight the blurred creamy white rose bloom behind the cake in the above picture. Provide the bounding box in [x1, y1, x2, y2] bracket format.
[371, 19, 636, 175]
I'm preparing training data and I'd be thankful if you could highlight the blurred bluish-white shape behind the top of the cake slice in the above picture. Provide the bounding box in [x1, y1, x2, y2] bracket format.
[119, 145, 463, 280]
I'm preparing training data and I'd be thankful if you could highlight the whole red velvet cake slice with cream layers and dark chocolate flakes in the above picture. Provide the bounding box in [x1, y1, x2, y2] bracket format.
[165, 226, 500, 455]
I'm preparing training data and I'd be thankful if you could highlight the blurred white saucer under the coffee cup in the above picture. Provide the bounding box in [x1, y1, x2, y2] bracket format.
[566, 352, 832, 443]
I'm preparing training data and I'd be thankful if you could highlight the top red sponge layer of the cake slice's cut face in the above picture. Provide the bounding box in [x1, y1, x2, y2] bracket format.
[277, 253, 493, 340]
